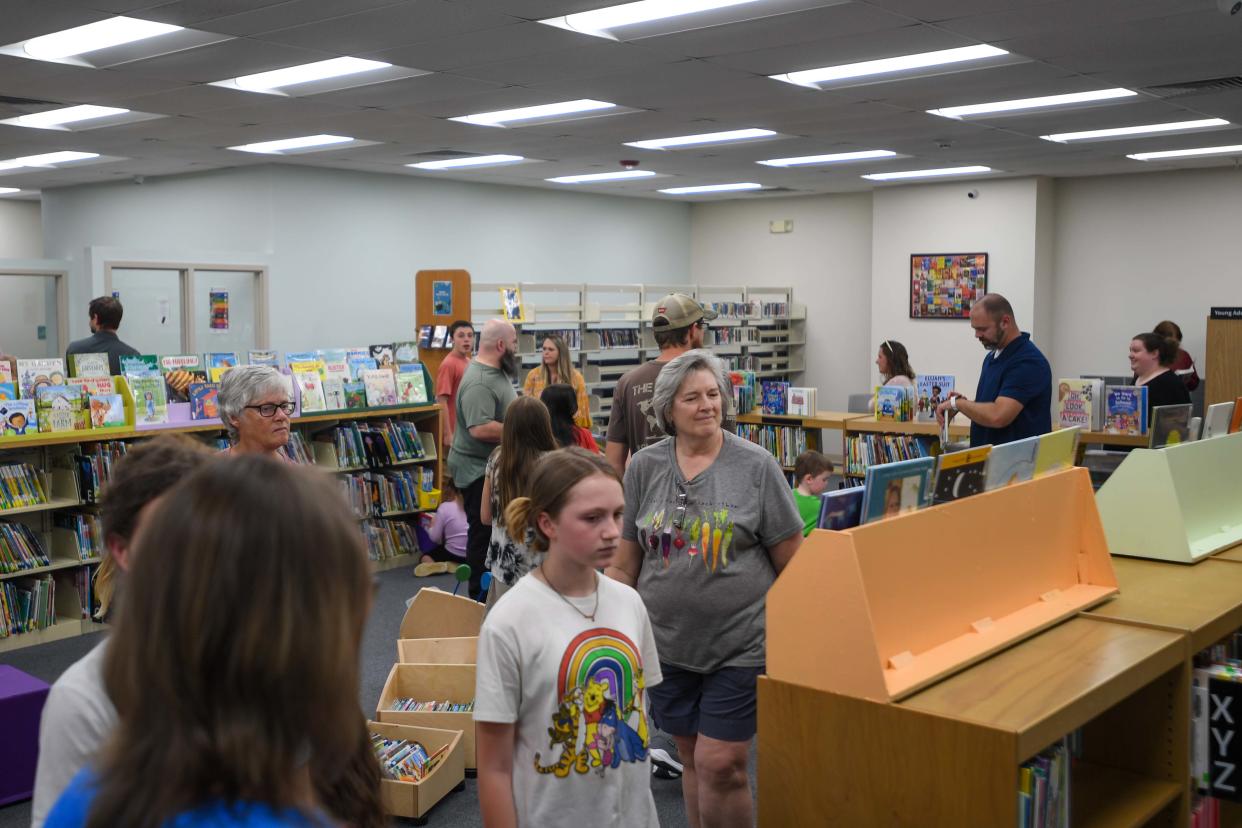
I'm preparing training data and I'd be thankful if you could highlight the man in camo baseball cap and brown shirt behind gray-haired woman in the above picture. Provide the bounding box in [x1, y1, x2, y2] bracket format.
[605, 293, 717, 475]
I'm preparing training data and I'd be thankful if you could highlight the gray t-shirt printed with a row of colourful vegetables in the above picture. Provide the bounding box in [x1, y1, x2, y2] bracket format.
[621, 432, 802, 673]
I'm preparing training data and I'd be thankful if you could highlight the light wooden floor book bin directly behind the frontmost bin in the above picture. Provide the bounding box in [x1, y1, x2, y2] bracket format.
[375, 664, 477, 770]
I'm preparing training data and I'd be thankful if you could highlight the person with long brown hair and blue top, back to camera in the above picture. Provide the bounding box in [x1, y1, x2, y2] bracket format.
[46, 456, 383, 828]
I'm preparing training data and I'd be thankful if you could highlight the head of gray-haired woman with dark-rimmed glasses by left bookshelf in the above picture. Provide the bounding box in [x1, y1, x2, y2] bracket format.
[217, 365, 293, 461]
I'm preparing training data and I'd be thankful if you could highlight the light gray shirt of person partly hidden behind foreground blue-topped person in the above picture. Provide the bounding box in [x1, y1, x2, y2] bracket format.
[30, 639, 117, 828]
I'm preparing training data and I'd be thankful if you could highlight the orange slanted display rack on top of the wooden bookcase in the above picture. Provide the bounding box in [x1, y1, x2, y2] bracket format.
[768, 468, 1117, 701]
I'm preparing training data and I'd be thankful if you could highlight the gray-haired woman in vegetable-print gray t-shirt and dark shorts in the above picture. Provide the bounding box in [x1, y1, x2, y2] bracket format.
[607, 349, 802, 827]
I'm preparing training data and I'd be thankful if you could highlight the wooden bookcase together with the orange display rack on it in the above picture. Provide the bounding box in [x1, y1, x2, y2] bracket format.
[759, 468, 1190, 826]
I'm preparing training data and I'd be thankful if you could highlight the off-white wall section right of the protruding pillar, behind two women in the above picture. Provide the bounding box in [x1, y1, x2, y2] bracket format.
[1051, 168, 1242, 376]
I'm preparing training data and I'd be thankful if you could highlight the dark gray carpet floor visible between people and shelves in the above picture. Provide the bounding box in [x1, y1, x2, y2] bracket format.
[0, 569, 710, 828]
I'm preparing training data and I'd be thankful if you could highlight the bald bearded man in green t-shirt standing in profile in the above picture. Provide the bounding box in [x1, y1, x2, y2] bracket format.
[448, 319, 518, 596]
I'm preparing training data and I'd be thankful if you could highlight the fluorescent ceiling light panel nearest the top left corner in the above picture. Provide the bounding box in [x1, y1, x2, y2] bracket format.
[0, 16, 232, 68]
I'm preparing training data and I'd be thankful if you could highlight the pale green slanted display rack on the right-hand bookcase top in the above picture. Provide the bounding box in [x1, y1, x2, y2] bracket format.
[1095, 433, 1242, 564]
